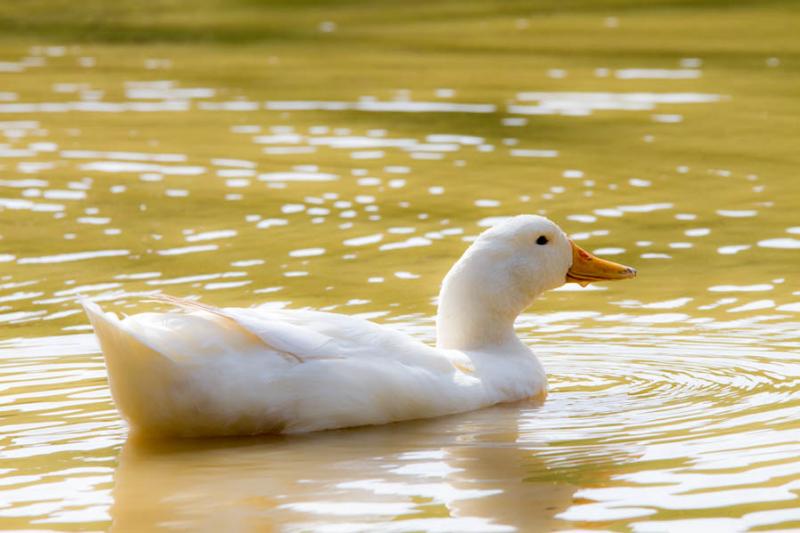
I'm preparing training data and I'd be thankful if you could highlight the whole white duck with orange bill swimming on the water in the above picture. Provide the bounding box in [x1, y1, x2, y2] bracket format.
[84, 215, 636, 437]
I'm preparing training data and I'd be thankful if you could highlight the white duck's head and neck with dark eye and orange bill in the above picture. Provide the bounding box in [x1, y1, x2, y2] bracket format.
[437, 215, 636, 349]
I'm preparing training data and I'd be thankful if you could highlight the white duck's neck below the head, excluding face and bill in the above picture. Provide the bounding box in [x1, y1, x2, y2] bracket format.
[436, 264, 536, 350]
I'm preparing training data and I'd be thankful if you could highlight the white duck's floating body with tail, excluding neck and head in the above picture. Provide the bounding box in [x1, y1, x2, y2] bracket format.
[86, 302, 547, 436]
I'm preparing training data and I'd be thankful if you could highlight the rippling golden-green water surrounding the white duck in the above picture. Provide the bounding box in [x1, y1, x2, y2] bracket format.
[0, 0, 800, 532]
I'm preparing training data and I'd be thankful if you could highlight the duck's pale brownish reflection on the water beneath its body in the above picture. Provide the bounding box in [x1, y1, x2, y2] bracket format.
[111, 404, 632, 532]
